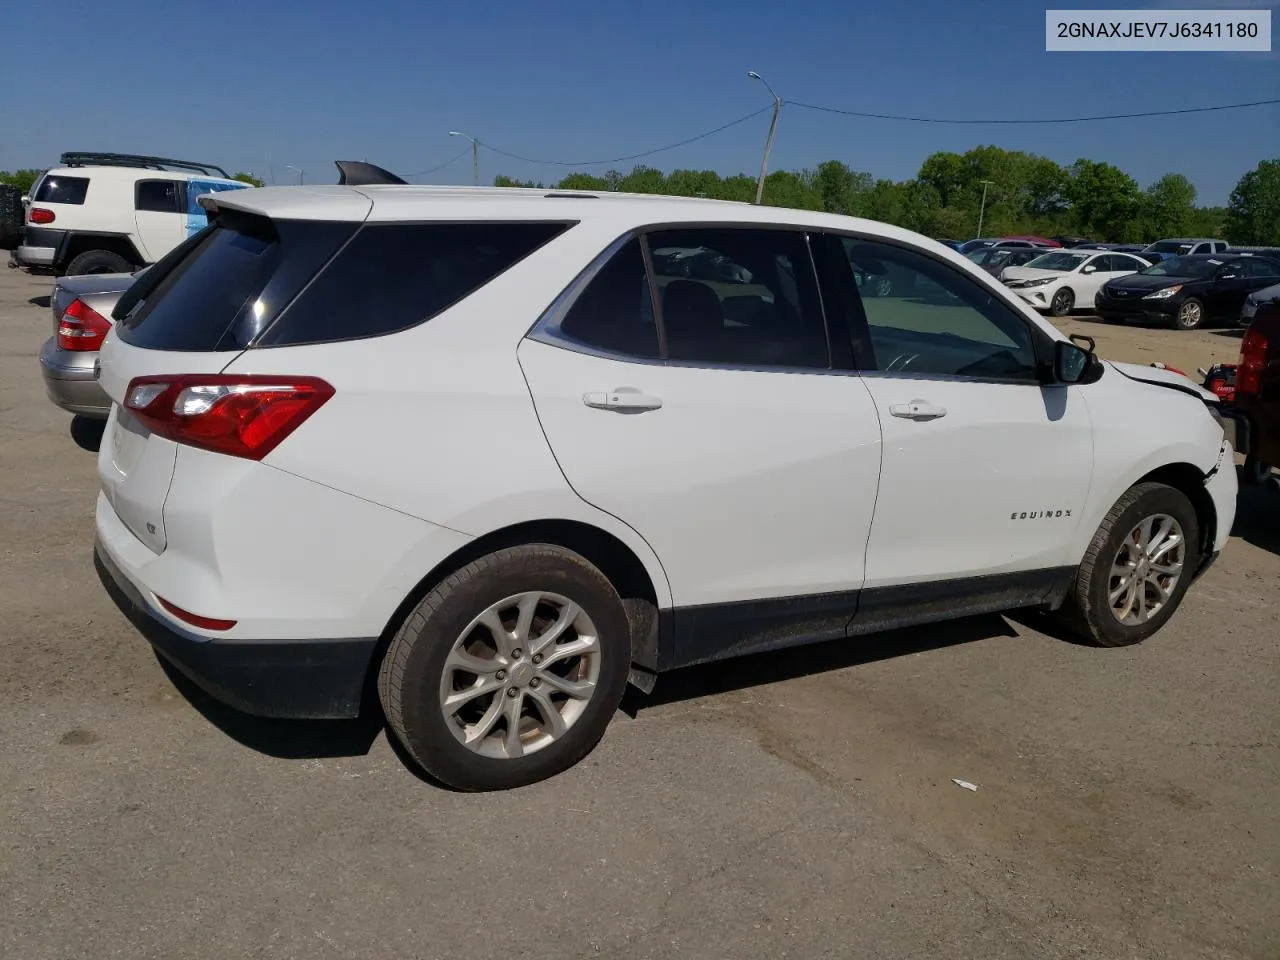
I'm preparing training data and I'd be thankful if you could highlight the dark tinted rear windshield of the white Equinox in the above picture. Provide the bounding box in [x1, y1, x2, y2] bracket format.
[118, 210, 358, 352]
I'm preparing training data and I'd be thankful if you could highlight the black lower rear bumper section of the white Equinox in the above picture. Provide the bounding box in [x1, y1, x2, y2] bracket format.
[93, 539, 378, 718]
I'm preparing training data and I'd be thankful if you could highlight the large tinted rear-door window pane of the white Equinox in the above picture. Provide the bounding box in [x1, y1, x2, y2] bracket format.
[646, 227, 831, 369]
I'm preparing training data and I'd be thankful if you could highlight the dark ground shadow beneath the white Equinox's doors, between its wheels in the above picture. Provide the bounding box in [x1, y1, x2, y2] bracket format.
[621, 613, 1018, 719]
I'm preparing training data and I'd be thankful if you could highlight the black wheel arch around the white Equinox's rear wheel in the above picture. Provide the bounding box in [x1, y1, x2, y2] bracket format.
[364, 520, 658, 705]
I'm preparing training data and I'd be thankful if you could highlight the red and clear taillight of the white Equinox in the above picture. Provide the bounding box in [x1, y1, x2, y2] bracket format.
[124, 374, 333, 460]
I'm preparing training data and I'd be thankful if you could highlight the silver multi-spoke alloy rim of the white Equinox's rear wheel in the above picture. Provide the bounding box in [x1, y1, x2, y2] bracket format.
[439, 591, 600, 759]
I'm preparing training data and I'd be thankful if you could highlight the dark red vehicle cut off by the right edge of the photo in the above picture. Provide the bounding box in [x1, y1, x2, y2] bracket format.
[1230, 303, 1280, 483]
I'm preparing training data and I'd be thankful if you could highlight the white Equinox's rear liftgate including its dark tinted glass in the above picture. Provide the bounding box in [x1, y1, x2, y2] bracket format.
[97, 211, 357, 553]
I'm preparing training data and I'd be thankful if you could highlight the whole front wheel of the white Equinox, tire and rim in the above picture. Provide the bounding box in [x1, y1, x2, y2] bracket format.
[1062, 483, 1199, 646]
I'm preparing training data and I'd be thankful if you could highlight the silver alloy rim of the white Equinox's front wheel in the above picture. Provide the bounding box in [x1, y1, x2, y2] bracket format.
[1107, 513, 1187, 626]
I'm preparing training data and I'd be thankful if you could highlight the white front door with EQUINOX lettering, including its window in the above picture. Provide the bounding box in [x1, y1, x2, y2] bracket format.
[844, 238, 1093, 599]
